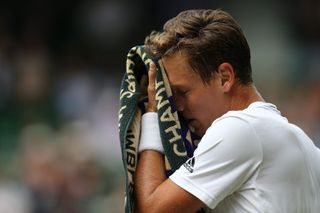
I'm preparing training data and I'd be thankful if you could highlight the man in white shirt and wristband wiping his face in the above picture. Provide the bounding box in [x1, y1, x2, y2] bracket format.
[135, 10, 320, 213]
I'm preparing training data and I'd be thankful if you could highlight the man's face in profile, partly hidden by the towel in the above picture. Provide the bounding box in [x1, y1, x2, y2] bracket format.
[162, 52, 226, 136]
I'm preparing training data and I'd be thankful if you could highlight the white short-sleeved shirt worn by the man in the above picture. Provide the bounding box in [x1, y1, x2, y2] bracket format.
[170, 102, 320, 213]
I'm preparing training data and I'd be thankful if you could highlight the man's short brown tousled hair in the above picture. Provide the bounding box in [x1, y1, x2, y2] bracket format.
[145, 9, 252, 84]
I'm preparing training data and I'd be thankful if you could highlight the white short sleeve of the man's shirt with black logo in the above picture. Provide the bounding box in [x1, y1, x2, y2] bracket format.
[170, 116, 262, 209]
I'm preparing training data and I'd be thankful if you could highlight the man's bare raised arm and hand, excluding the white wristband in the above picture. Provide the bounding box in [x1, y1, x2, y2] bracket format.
[135, 64, 203, 213]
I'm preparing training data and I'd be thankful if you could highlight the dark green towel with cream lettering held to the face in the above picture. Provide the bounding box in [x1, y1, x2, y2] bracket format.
[119, 46, 199, 213]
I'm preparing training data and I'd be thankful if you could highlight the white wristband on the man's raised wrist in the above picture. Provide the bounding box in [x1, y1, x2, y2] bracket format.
[139, 112, 164, 154]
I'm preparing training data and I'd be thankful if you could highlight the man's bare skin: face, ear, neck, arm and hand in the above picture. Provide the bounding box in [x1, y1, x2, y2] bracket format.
[135, 52, 263, 213]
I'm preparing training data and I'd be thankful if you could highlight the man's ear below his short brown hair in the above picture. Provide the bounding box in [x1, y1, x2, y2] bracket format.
[217, 63, 235, 92]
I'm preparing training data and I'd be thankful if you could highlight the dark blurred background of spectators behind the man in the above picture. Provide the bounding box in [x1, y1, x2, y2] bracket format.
[0, 0, 320, 213]
